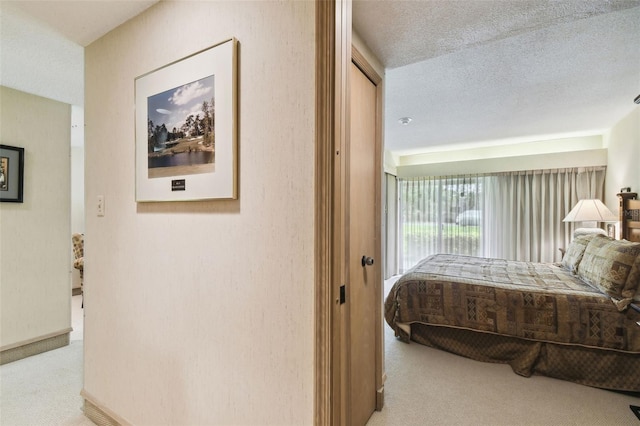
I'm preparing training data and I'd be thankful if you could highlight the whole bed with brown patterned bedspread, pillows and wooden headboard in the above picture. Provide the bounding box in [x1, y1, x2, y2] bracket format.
[384, 193, 640, 392]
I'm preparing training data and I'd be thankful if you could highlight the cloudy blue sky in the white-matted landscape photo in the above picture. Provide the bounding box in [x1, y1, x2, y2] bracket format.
[147, 75, 214, 132]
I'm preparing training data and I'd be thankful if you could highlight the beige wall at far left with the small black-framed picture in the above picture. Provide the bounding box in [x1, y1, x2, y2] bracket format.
[0, 87, 71, 349]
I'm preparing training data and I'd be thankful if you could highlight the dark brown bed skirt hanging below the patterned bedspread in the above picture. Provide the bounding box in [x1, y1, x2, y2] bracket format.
[399, 323, 640, 392]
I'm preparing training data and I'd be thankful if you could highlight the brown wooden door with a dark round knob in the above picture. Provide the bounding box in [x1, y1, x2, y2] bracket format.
[346, 63, 382, 425]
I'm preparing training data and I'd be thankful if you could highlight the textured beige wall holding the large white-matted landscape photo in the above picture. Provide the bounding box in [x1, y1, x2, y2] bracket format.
[84, 1, 315, 425]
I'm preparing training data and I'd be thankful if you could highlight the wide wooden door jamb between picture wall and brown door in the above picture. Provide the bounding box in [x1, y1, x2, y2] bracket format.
[314, 0, 351, 426]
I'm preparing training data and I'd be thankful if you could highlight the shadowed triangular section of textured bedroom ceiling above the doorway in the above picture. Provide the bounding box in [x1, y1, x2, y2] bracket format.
[353, 0, 640, 68]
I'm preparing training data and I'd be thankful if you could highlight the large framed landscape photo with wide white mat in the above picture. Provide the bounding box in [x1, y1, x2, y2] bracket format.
[135, 39, 238, 202]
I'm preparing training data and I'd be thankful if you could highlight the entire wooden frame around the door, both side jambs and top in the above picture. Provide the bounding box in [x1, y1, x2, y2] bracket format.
[313, 0, 384, 426]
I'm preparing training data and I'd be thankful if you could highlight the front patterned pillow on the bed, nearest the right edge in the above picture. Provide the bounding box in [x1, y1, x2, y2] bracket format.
[578, 235, 640, 310]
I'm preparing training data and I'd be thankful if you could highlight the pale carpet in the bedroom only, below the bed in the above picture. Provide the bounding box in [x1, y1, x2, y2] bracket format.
[367, 279, 640, 426]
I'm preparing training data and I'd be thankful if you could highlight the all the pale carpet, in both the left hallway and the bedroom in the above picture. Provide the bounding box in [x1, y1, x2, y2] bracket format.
[0, 292, 640, 426]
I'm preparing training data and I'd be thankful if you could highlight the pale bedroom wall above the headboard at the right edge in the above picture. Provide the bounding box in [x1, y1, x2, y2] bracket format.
[605, 106, 640, 214]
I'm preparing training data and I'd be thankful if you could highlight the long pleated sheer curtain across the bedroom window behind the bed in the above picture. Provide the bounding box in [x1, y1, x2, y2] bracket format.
[399, 167, 605, 272]
